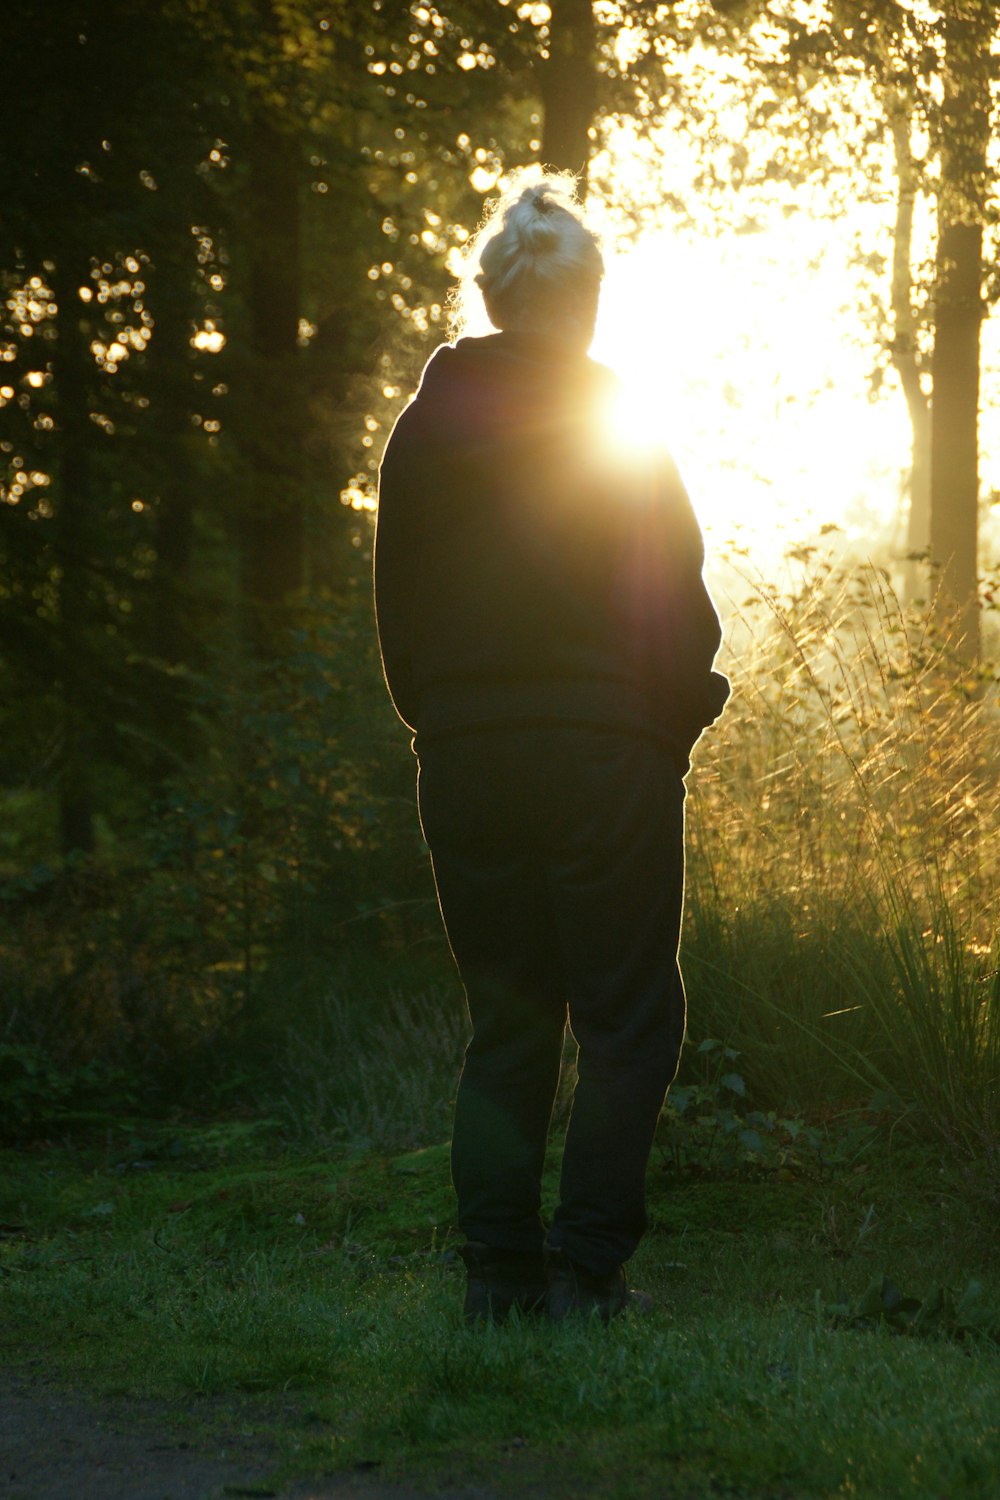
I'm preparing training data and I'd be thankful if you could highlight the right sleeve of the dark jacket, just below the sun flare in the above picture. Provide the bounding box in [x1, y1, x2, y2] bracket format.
[625, 452, 730, 755]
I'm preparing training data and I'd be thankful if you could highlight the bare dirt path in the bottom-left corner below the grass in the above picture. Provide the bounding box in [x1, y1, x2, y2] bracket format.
[0, 1368, 493, 1500]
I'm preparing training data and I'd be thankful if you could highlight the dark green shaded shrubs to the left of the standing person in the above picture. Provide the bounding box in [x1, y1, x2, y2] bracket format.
[0, 585, 450, 1100]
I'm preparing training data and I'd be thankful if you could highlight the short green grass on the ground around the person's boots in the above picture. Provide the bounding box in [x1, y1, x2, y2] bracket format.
[0, 1125, 1000, 1500]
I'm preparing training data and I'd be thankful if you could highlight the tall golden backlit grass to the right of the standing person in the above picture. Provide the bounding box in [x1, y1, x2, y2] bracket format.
[687, 567, 1000, 1185]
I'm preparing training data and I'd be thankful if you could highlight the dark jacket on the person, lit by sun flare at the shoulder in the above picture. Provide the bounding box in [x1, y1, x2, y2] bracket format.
[375, 333, 729, 759]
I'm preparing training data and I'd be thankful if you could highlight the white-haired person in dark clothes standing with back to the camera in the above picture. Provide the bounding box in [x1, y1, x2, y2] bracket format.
[375, 174, 729, 1322]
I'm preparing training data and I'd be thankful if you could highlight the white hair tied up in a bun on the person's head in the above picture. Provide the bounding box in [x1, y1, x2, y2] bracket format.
[450, 167, 604, 335]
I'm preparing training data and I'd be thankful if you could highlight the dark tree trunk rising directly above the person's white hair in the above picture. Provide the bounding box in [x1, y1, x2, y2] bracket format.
[540, 0, 597, 186]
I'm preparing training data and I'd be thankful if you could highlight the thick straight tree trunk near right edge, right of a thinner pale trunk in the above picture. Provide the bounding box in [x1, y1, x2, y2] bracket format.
[930, 5, 993, 660]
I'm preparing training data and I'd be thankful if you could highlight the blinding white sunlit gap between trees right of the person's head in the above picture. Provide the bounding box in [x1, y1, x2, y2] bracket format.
[581, 71, 1000, 585]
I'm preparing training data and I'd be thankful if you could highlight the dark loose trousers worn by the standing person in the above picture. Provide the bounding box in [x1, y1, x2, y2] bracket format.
[418, 726, 685, 1275]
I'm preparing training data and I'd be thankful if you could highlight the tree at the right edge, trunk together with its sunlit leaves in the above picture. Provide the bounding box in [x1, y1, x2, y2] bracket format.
[786, 0, 1000, 659]
